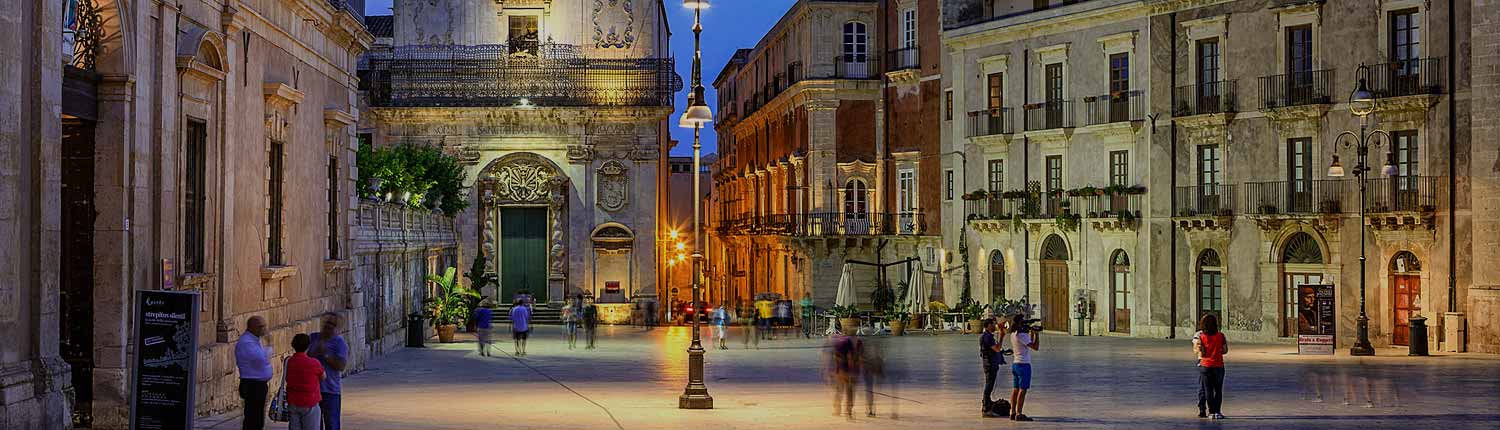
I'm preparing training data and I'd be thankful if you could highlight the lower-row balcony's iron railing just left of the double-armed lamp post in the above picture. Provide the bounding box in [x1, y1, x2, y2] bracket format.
[1242, 180, 1358, 214]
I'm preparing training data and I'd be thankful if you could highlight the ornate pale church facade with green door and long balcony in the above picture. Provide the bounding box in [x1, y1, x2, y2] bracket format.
[359, 0, 683, 321]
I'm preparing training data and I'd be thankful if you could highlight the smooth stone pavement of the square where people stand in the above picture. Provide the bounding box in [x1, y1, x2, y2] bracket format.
[200, 327, 1500, 430]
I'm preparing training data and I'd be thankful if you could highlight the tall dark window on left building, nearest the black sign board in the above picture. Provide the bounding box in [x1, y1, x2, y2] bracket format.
[183, 120, 209, 273]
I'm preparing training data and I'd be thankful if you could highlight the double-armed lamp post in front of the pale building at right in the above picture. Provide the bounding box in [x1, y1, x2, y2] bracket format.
[1328, 64, 1397, 355]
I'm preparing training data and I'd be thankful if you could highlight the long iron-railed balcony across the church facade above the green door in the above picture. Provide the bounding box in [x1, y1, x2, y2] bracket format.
[368, 43, 683, 108]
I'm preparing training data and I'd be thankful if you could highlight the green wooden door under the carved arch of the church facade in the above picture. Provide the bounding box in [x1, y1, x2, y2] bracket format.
[498, 208, 548, 303]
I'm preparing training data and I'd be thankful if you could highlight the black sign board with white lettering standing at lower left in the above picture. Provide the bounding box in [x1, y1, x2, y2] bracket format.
[131, 291, 198, 430]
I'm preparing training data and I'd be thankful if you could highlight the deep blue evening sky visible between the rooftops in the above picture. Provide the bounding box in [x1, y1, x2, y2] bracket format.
[365, 0, 797, 156]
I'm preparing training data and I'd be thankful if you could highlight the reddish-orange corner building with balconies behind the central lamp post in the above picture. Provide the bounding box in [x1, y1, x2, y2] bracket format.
[708, 0, 942, 307]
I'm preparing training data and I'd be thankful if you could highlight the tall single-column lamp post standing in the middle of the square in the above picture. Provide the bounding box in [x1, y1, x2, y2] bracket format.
[677, 0, 714, 409]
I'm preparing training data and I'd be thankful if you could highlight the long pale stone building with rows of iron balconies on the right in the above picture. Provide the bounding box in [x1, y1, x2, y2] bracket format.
[944, 0, 1497, 351]
